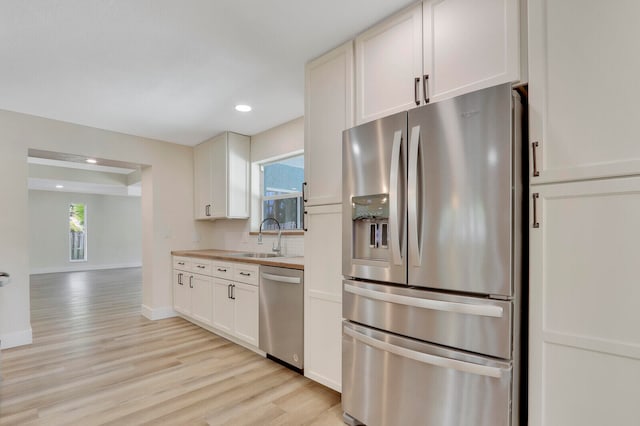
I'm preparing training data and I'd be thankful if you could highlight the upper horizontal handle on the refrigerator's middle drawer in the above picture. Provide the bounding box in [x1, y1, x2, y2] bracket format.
[344, 282, 504, 318]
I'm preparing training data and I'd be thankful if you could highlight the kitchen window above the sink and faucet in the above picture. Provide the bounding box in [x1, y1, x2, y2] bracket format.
[261, 155, 304, 230]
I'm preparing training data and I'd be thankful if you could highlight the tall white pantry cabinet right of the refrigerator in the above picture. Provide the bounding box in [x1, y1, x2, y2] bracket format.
[528, 0, 640, 426]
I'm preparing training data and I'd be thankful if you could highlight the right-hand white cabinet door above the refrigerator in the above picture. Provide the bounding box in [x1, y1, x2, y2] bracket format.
[423, 0, 520, 101]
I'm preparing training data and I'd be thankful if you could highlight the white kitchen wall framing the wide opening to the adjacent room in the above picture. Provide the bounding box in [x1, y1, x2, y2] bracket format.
[0, 111, 211, 347]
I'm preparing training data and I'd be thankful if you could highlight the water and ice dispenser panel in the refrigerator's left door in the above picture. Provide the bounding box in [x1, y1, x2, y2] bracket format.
[351, 194, 389, 260]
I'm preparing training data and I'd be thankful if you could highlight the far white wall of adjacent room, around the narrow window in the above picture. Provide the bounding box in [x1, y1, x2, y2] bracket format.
[29, 190, 142, 274]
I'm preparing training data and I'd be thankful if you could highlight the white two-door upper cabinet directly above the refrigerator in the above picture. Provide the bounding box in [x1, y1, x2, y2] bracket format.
[355, 0, 526, 124]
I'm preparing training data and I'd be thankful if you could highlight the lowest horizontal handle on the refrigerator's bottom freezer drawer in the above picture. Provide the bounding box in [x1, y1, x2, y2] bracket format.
[342, 327, 502, 379]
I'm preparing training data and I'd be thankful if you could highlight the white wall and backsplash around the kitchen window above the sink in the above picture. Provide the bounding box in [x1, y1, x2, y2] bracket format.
[202, 117, 304, 256]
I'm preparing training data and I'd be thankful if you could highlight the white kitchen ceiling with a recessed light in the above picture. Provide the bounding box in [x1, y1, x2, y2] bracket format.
[0, 0, 414, 145]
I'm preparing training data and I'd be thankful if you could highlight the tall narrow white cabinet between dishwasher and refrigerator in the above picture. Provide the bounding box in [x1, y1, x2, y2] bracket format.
[304, 41, 353, 391]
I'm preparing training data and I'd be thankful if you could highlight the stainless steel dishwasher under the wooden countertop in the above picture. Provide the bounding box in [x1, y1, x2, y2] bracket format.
[259, 266, 304, 373]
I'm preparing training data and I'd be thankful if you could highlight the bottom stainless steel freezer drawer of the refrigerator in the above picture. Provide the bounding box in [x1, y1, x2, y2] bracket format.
[342, 322, 512, 426]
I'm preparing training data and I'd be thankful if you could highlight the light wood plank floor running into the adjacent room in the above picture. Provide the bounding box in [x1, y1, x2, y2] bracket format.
[0, 268, 342, 425]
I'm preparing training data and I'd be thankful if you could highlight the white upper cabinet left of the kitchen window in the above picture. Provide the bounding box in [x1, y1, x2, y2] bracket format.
[194, 132, 251, 219]
